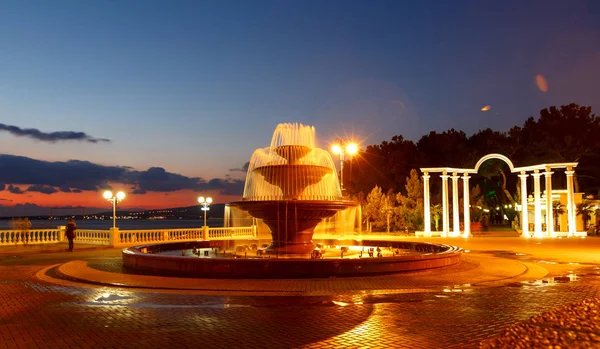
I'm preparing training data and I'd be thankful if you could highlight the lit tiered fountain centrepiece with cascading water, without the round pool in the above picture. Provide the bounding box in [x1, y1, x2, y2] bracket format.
[228, 124, 357, 254]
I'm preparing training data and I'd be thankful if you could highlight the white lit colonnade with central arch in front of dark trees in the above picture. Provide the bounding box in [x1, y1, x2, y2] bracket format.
[421, 154, 577, 237]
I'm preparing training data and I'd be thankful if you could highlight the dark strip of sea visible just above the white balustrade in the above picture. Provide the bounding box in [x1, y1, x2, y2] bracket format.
[0, 219, 223, 230]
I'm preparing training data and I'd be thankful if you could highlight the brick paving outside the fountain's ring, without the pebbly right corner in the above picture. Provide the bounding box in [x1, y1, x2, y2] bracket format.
[0, 237, 600, 348]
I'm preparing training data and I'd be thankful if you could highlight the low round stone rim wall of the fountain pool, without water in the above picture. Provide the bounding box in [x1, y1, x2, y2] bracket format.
[122, 240, 462, 278]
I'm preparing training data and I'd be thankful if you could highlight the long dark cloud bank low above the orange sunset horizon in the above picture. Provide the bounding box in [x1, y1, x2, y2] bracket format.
[0, 154, 244, 195]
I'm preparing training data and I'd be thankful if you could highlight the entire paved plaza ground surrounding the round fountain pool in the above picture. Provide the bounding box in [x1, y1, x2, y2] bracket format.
[0, 237, 600, 348]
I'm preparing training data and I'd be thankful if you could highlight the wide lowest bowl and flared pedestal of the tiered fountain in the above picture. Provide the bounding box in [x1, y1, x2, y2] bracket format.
[228, 200, 356, 254]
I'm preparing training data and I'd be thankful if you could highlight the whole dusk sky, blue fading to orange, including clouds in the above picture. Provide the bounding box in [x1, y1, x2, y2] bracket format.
[0, 0, 600, 215]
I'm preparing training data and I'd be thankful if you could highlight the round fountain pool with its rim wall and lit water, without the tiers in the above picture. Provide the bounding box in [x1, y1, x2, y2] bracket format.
[123, 240, 462, 278]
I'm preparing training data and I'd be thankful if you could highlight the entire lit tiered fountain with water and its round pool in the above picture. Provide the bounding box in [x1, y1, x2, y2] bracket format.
[122, 124, 461, 278]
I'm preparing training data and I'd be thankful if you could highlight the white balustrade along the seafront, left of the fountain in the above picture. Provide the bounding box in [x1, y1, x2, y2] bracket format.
[0, 227, 256, 247]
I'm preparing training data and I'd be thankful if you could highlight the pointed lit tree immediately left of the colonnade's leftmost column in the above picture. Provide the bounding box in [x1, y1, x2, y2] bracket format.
[396, 169, 423, 231]
